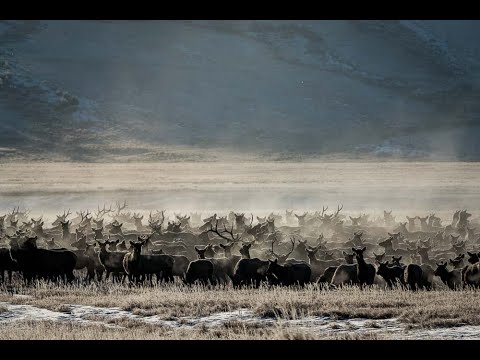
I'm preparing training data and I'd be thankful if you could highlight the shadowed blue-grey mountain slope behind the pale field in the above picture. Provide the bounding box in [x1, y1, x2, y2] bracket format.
[0, 21, 480, 161]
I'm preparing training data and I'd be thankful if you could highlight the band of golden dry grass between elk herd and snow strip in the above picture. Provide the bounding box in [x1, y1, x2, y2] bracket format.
[0, 283, 480, 328]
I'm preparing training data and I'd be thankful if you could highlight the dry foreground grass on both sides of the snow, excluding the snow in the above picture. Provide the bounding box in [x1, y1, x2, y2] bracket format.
[0, 284, 480, 339]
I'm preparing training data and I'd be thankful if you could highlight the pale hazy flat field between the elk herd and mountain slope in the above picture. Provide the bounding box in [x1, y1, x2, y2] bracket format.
[0, 162, 480, 221]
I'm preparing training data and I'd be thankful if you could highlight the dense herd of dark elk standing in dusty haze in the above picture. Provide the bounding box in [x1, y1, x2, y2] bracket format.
[0, 202, 480, 290]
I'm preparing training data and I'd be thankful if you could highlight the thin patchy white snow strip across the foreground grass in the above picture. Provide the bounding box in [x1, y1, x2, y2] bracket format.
[0, 302, 480, 340]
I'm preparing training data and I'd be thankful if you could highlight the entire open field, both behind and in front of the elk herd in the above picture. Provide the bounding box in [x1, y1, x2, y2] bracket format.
[0, 162, 480, 339]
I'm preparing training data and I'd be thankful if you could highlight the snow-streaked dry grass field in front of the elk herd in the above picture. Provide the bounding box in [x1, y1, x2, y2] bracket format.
[0, 284, 480, 339]
